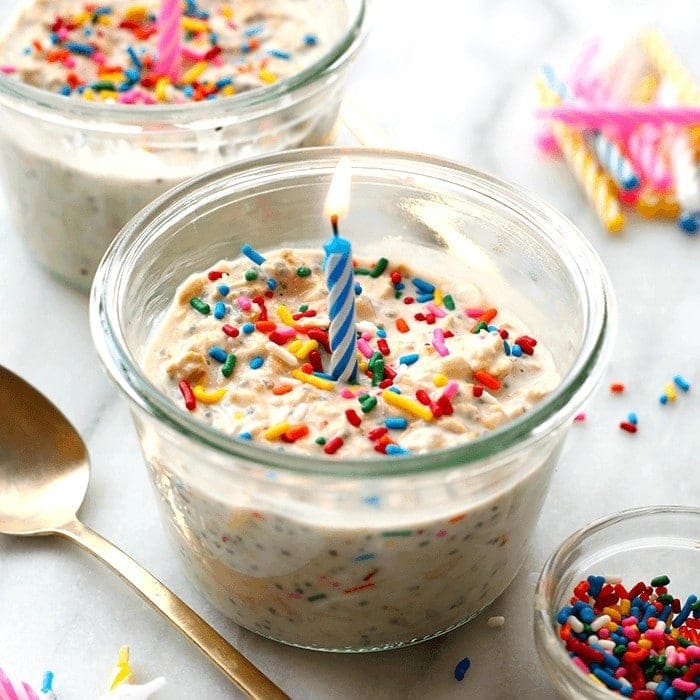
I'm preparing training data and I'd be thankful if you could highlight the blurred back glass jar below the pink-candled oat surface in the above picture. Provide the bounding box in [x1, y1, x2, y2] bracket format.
[0, 0, 367, 291]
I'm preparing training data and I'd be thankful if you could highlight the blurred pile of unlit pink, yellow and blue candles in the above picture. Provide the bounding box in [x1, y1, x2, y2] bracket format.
[537, 31, 700, 233]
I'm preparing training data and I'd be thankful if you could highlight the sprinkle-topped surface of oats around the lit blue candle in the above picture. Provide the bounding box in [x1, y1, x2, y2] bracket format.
[145, 249, 559, 457]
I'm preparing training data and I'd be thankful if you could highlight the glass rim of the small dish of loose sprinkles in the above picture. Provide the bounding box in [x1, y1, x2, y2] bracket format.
[534, 505, 700, 700]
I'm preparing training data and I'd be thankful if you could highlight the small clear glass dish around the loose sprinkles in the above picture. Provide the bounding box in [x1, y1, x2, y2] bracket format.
[534, 506, 700, 700]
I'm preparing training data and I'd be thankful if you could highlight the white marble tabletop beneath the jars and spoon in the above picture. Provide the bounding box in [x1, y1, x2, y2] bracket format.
[0, 0, 700, 700]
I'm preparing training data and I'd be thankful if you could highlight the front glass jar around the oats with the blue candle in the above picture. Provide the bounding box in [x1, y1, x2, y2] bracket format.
[91, 149, 614, 651]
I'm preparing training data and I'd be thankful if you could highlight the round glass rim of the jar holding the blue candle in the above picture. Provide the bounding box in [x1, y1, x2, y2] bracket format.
[90, 147, 615, 477]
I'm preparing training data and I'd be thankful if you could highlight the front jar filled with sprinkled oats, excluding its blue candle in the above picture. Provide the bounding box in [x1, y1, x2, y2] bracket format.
[91, 150, 608, 651]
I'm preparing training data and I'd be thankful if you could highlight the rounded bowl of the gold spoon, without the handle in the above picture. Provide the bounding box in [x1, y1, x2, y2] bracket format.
[0, 367, 90, 535]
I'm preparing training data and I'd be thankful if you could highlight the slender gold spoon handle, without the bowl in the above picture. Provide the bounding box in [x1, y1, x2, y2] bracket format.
[55, 520, 290, 700]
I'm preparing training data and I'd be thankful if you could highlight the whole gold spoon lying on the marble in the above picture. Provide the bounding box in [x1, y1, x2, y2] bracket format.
[0, 366, 289, 700]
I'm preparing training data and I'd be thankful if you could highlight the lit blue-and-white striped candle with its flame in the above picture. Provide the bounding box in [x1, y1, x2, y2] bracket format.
[323, 158, 357, 383]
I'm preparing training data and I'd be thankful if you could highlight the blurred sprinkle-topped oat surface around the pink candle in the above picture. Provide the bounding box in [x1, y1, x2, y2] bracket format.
[0, 0, 326, 104]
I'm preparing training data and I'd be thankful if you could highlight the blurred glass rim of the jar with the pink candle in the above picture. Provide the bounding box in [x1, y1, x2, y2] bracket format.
[0, 0, 369, 125]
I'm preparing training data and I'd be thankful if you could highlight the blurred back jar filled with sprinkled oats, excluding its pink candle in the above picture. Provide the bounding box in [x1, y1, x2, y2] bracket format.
[0, 0, 364, 289]
